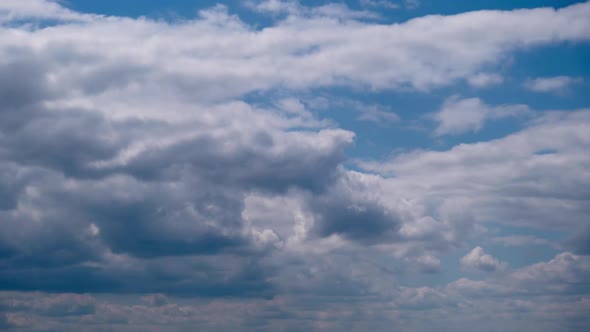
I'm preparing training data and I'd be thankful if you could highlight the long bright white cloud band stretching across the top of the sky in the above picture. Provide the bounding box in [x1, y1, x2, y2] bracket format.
[1, 2, 590, 100]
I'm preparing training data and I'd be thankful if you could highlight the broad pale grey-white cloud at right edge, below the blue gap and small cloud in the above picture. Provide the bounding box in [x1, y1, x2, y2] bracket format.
[359, 110, 590, 233]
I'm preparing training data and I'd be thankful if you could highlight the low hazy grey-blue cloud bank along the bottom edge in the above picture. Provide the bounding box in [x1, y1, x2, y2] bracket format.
[0, 252, 590, 331]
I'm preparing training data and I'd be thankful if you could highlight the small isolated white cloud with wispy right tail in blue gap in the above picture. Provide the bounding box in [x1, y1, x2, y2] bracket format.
[433, 96, 530, 136]
